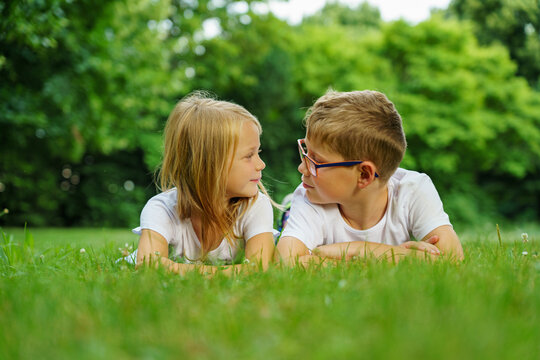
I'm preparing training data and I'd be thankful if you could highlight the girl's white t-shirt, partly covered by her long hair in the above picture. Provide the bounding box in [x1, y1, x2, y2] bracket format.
[133, 188, 274, 262]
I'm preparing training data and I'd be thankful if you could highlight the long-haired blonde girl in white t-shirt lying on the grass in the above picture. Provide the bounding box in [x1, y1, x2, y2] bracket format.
[134, 92, 274, 274]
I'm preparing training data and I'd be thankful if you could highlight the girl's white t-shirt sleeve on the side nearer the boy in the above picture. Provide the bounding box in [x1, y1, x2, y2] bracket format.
[242, 193, 274, 241]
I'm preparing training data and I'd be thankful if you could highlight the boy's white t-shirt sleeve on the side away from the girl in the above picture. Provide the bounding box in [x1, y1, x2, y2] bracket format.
[409, 174, 452, 240]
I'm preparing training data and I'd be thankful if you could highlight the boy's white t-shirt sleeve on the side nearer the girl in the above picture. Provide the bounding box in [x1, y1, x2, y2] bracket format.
[281, 186, 324, 251]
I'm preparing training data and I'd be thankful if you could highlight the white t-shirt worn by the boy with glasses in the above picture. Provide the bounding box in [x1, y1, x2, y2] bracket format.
[282, 169, 451, 250]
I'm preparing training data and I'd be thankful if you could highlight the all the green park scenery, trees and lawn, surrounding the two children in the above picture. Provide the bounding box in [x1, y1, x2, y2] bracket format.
[0, 0, 540, 360]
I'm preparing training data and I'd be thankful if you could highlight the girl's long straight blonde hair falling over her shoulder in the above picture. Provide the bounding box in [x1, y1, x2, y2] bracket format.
[158, 91, 267, 258]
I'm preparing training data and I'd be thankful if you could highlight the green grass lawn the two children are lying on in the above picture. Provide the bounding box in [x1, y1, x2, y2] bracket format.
[0, 226, 540, 359]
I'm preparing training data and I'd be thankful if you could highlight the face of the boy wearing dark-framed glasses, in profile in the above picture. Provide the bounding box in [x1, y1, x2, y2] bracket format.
[298, 138, 358, 204]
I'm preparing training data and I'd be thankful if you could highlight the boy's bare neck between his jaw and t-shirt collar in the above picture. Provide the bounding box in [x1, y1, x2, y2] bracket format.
[338, 183, 388, 230]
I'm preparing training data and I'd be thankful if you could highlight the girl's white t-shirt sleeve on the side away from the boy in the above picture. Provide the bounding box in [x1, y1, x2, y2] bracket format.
[140, 197, 178, 243]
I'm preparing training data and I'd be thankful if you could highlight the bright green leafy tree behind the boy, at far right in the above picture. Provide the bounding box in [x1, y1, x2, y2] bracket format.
[381, 16, 540, 222]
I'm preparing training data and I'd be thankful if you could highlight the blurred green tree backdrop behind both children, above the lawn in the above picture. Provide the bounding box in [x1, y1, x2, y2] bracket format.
[0, 0, 540, 228]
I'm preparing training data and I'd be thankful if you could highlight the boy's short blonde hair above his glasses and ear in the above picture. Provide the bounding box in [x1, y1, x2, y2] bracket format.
[305, 90, 407, 181]
